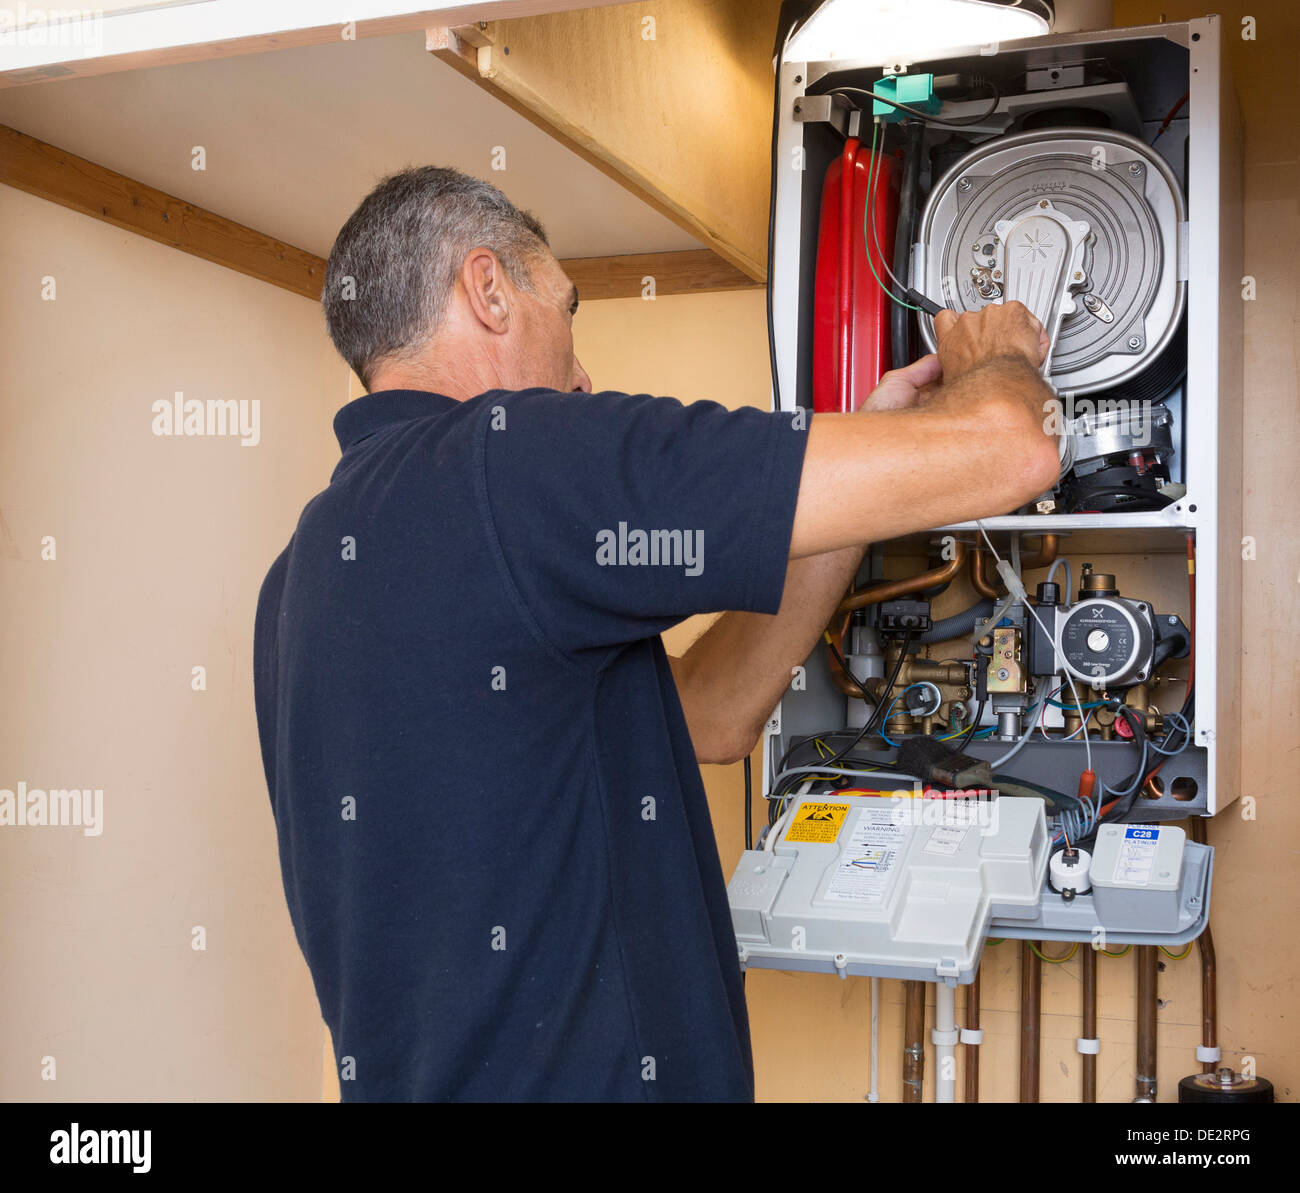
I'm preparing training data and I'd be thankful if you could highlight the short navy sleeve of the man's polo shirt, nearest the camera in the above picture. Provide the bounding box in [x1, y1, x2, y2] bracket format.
[476, 390, 807, 655]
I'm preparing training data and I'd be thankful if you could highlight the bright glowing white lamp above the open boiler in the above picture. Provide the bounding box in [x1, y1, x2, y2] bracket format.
[785, 0, 1053, 66]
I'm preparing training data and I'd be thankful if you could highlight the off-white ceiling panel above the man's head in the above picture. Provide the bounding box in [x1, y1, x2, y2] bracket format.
[0, 34, 699, 257]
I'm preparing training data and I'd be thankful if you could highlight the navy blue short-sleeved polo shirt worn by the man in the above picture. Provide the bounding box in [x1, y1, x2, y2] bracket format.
[255, 390, 806, 1101]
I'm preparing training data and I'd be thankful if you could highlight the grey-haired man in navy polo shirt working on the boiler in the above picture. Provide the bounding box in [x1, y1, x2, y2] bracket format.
[255, 168, 1057, 1101]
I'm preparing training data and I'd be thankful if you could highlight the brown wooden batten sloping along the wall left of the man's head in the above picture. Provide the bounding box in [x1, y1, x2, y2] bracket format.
[0, 125, 325, 299]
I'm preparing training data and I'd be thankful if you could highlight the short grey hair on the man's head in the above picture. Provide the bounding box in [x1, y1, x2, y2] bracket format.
[321, 166, 550, 390]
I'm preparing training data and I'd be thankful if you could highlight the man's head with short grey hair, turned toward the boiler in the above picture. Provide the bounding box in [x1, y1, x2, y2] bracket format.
[321, 166, 590, 399]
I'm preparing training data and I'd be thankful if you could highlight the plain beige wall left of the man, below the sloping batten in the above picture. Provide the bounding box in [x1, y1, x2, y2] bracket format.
[0, 187, 347, 1099]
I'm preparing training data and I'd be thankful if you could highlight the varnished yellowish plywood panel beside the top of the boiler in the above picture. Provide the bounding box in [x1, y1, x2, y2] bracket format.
[426, 0, 779, 282]
